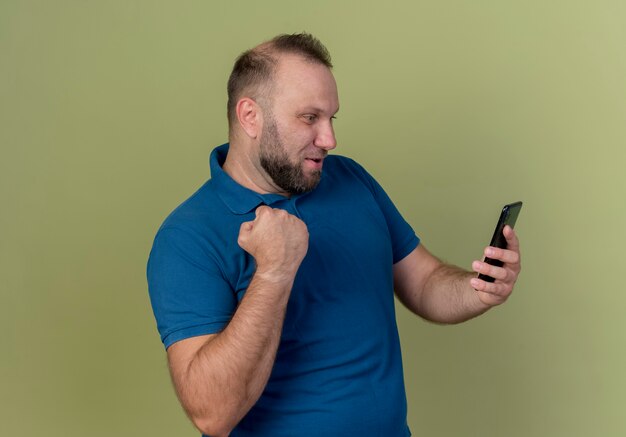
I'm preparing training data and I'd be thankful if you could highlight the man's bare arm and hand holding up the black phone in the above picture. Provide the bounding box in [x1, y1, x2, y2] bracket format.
[393, 226, 521, 323]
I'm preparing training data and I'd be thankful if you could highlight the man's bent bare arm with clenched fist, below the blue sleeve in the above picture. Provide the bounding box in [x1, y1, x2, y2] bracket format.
[162, 206, 308, 437]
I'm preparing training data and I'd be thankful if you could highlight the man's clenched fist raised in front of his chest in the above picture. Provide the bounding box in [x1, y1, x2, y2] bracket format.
[237, 206, 309, 280]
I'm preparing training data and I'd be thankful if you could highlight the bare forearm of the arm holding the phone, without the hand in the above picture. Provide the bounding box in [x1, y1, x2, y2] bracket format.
[419, 264, 490, 323]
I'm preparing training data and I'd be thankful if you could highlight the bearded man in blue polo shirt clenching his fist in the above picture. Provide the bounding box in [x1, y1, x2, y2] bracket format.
[148, 34, 520, 437]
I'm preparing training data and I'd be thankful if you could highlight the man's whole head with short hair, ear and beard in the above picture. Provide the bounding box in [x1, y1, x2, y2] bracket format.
[228, 34, 339, 194]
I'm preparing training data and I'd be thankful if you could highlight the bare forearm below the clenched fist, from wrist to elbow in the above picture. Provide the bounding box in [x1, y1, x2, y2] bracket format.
[174, 275, 293, 435]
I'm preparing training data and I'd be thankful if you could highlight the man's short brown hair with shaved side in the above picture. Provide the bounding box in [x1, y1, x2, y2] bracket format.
[227, 33, 333, 131]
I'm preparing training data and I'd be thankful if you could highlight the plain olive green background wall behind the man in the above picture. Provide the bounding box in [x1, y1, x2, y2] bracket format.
[0, 0, 626, 437]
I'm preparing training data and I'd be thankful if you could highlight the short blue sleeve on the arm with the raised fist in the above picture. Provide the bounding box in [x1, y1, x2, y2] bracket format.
[147, 227, 237, 348]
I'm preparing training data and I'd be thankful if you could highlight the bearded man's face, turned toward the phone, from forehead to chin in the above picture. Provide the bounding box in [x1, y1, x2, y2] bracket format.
[259, 56, 339, 194]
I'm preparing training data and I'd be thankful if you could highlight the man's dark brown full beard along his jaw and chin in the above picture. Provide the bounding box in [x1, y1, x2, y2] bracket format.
[259, 114, 322, 194]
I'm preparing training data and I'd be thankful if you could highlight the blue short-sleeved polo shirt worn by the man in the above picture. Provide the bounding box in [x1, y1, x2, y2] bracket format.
[148, 144, 419, 437]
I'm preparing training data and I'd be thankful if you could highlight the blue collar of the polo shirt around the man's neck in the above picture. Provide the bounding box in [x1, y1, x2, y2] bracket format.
[209, 143, 285, 214]
